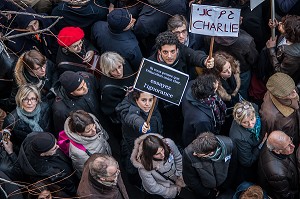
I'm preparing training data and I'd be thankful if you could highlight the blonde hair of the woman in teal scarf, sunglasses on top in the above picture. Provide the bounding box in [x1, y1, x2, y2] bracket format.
[233, 101, 255, 124]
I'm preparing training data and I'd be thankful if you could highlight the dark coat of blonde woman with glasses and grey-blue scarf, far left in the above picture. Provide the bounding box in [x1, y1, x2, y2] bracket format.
[3, 102, 53, 152]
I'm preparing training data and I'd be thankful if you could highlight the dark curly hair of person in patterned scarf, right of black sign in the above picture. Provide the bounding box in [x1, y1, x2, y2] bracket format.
[191, 74, 217, 100]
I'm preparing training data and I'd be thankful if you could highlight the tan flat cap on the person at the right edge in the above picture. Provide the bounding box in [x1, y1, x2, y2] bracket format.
[267, 73, 296, 98]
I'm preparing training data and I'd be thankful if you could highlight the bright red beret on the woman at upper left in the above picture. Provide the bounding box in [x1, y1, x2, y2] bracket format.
[57, 27, 84, 47]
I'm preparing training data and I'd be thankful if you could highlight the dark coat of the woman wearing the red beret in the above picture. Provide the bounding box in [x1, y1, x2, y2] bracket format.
[56, 39, 97, 75]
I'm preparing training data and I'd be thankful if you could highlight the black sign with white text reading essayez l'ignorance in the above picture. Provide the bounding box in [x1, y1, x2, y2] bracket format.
[134, 59, 189, 105]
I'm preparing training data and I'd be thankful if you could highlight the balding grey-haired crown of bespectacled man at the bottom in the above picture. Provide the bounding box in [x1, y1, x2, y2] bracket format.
[89, 154, 119, 179]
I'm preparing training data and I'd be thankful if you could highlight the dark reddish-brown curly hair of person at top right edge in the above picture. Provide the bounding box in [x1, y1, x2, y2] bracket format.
[282, 15, 300, 43]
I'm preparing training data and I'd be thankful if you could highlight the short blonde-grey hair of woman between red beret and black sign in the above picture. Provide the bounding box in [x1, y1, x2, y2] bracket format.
[100, 52, 125, 76]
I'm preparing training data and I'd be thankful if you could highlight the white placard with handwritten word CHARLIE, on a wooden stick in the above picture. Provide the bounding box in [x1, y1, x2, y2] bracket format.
[189, 4, 241, 37]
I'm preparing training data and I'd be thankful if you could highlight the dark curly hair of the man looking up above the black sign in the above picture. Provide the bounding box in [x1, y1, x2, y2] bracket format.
[155, 31, 179, 50]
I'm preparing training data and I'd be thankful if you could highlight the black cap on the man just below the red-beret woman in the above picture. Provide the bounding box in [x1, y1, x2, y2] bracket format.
[59, 71, 83, 93]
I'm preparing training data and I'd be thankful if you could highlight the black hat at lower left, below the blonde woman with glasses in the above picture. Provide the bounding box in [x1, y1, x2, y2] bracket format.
[31, 132, 56, 154]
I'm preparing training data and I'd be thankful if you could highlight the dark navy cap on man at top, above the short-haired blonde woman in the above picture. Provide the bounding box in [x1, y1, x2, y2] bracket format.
[107, 9, 131, 33]
